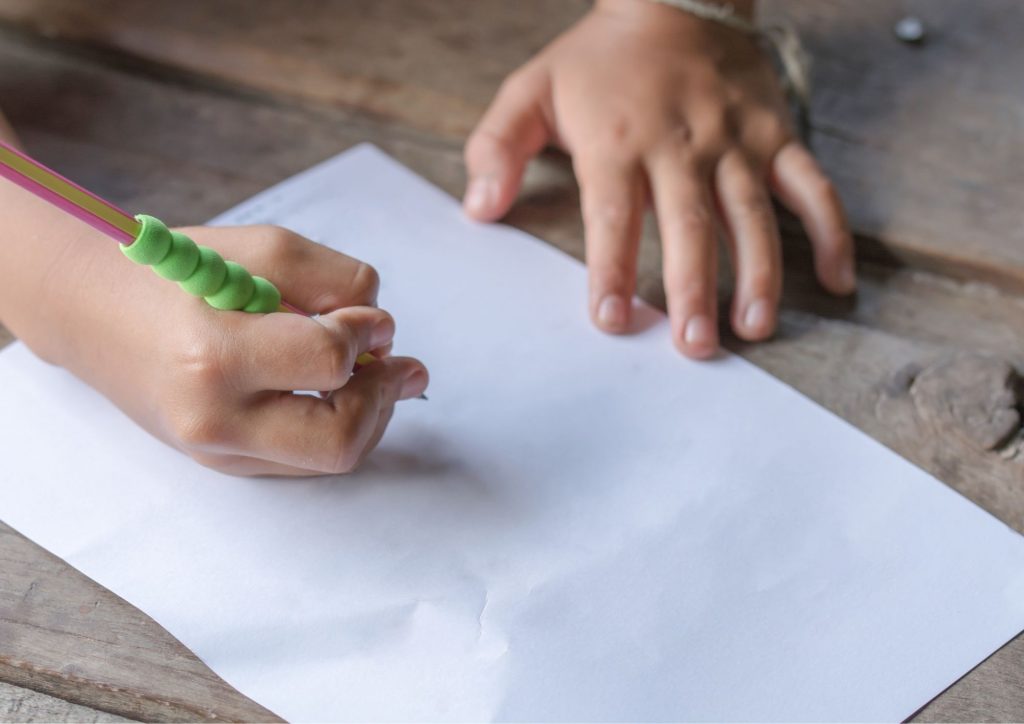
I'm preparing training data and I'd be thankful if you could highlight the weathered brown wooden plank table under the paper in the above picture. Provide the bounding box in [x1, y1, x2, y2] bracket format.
[0, 0, 1024, 721]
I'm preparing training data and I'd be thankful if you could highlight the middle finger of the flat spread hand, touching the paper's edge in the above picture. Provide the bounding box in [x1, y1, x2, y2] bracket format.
[647, 155, 718, 358]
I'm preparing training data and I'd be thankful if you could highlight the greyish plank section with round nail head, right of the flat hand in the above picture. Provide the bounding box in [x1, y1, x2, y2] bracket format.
[765, 0, 1024, 291]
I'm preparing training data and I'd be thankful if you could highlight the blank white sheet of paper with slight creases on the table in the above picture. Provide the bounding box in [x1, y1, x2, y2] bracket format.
[0, 146, 1024, 721]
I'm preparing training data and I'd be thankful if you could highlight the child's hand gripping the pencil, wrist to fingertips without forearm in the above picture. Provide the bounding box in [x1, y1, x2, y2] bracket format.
[128, 227, 427, 475]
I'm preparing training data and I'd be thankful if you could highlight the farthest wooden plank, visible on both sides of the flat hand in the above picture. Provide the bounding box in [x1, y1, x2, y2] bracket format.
[0, 0, 1024, 290]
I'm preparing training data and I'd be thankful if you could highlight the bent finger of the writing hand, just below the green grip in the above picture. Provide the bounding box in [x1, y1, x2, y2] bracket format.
[228, 307, 394, 392]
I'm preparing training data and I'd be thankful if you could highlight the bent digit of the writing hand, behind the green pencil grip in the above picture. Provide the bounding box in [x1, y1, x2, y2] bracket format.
[181, 225, 380, 314]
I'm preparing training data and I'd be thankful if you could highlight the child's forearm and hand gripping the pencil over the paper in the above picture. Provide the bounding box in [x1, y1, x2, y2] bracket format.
[0, 200, 427, 475]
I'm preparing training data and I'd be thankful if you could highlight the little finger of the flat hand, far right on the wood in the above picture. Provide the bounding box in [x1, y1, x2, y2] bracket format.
[770, 141, 857, 294]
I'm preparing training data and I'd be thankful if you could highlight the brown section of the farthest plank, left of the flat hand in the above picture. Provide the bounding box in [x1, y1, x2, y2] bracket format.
[0, 0, 590, 137]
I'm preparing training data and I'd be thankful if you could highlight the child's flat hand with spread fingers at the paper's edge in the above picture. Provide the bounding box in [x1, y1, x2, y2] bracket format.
[464, 0, 856, 357]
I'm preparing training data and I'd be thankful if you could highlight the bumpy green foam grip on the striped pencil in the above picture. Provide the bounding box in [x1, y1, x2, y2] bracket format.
[121, 214, 281, 313]
